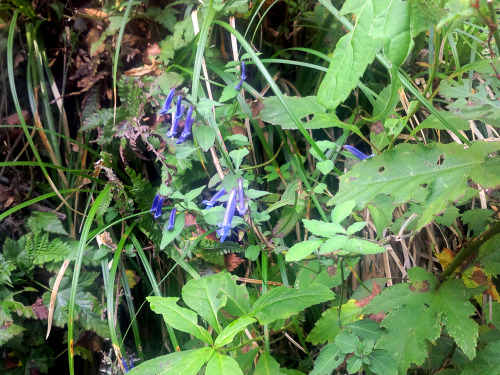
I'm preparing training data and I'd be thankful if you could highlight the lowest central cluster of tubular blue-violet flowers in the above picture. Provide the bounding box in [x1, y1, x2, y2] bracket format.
[203, 178, 247, 242]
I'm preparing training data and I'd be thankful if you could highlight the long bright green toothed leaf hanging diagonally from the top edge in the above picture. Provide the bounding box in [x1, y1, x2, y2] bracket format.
[318, 0, 387, 110]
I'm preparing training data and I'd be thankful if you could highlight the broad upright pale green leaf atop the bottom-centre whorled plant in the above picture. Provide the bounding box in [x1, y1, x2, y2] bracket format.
[182, 275, 227, 333]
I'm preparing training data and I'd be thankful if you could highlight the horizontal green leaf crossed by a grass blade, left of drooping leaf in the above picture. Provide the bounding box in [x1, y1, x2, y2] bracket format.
[259, 96, 346, 131]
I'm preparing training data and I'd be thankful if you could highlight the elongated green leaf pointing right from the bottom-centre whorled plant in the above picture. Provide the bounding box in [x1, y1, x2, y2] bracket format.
[252, 285, 335, 324]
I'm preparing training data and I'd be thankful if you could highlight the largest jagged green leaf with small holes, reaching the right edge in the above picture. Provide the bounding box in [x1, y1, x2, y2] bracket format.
[329, 142, 500, 229]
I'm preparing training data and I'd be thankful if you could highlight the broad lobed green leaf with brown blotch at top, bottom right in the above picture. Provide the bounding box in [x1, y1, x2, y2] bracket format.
[364, 268, 478, 373]
